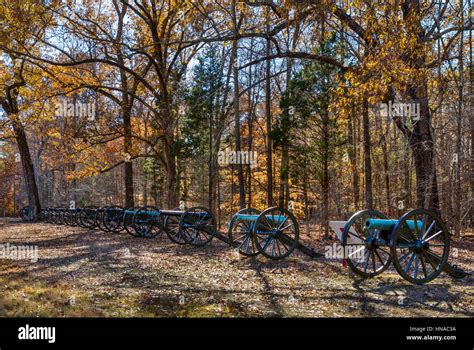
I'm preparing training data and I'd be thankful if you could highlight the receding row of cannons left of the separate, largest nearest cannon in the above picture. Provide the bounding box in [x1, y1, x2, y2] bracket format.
[40, 206, 302, 260]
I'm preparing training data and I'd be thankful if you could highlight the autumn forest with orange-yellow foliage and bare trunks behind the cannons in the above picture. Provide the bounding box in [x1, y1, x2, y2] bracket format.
[0, 0, 474, 236]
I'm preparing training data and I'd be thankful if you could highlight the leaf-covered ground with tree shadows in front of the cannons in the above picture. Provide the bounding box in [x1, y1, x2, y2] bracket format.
[0, 218, 474, 317]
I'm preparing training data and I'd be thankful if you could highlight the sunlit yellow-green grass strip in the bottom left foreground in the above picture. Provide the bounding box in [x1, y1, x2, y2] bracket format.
[0, 279, 248, 317]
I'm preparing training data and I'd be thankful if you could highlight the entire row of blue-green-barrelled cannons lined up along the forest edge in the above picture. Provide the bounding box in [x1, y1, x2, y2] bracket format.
[21, 206, 467, 284]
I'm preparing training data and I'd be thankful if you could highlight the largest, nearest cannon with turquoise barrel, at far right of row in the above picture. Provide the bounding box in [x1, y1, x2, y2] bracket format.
[334, 209, 466, 284]
